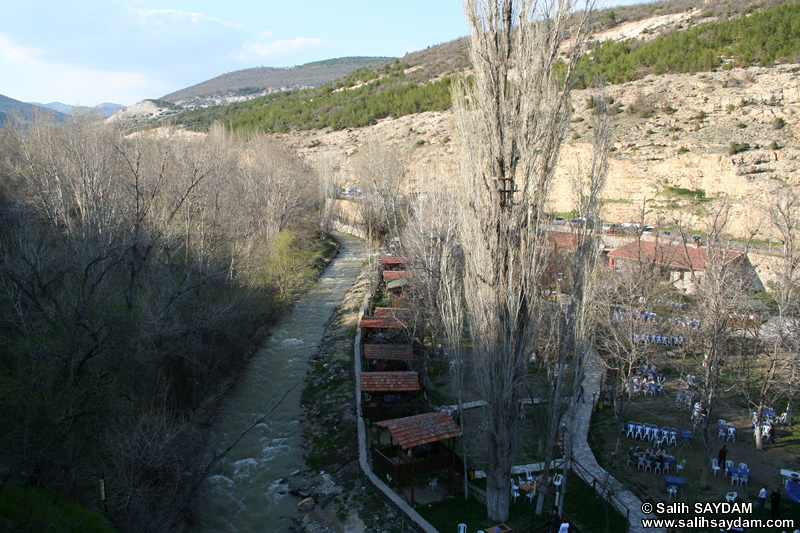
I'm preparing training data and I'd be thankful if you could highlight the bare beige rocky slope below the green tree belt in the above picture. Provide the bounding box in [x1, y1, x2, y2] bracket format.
[279, 65, 800, 237]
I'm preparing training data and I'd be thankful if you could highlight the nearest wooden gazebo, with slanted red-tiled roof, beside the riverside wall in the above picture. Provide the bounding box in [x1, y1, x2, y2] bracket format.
[374, 412, 462, 505]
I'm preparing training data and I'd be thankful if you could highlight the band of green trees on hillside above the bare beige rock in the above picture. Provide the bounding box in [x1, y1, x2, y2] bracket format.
[172, 3, 800, 132]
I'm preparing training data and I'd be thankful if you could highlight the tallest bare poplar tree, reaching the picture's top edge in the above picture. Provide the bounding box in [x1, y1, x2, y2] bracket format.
[453, 0, 590, 521]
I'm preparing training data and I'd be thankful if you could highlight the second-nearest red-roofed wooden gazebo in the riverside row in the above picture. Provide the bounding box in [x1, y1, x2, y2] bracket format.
[358, 372, 419, 420]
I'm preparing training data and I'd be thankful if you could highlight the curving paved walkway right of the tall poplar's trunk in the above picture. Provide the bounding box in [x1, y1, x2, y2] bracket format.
[570, 351, 664, 533]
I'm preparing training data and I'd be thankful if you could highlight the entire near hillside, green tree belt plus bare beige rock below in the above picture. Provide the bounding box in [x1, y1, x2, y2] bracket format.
[123, 1, 800, 239]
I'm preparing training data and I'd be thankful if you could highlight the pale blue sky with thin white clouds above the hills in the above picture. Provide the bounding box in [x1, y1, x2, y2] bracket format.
[0, 0, 636, 106]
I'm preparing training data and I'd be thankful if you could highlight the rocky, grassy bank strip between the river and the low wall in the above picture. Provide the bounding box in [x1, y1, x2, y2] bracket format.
[296, 256, 401, 533]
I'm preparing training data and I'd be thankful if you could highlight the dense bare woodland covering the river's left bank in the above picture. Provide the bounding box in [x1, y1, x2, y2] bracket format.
[0, 116, 332, 531]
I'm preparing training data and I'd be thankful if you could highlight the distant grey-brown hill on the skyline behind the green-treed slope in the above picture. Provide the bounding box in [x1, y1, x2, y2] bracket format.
[161, 57, 391, 109]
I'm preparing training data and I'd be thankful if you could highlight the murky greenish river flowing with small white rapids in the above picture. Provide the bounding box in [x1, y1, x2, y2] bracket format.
[198, 234, 365, 533]
